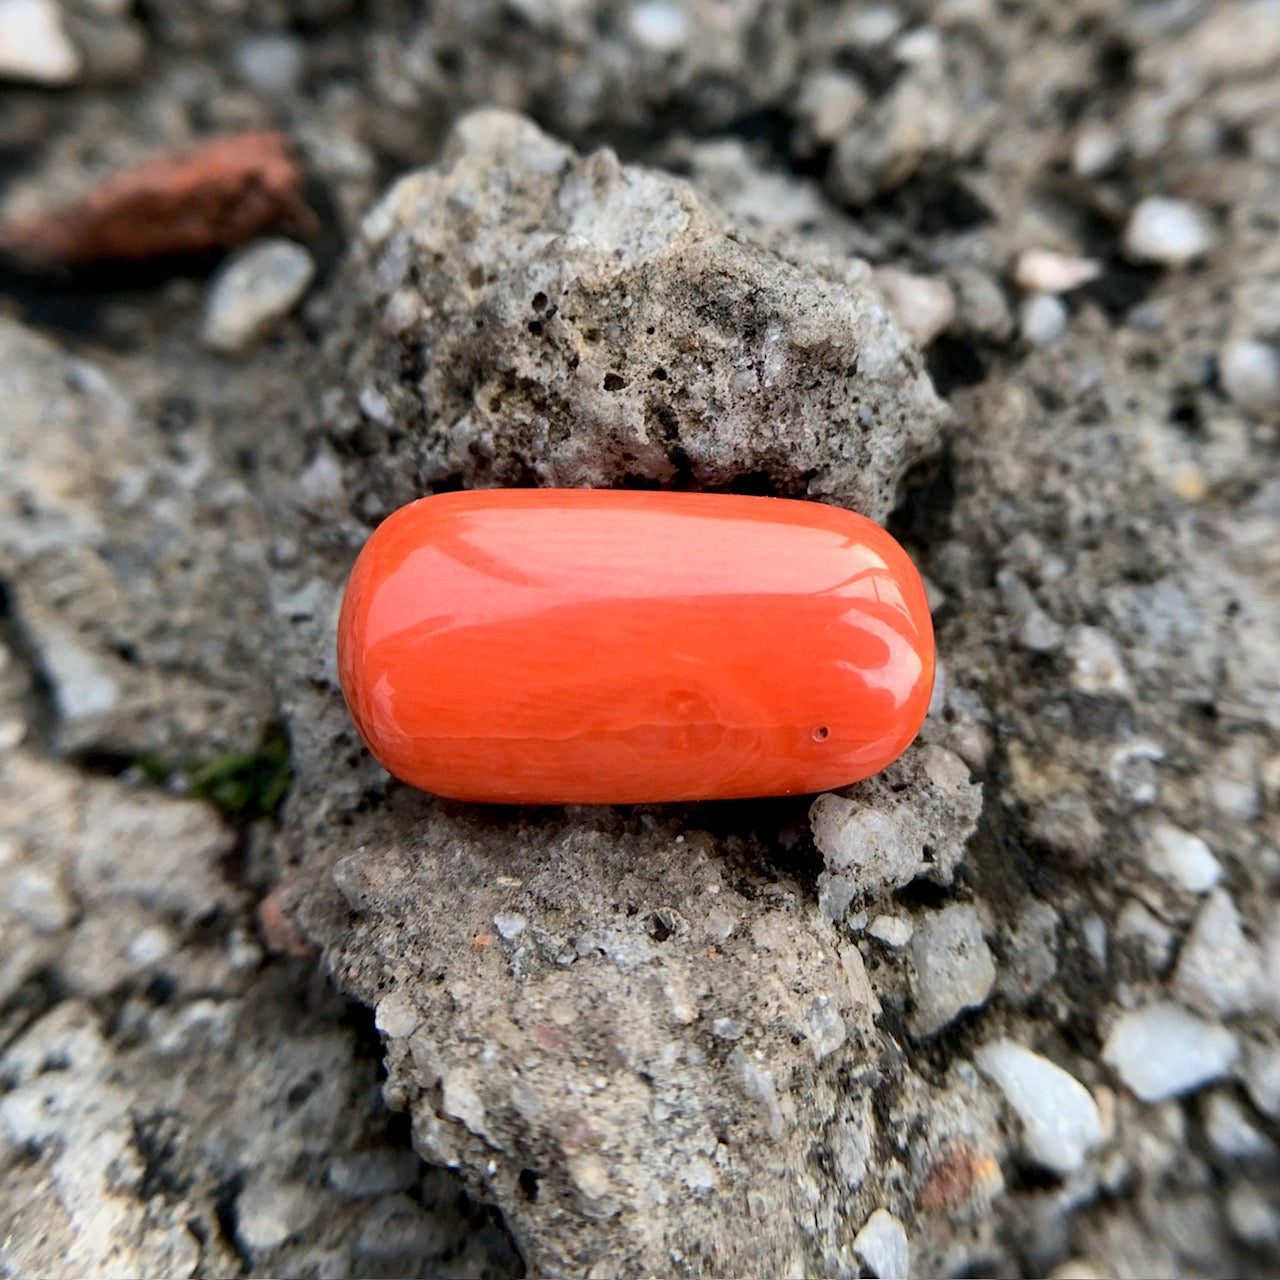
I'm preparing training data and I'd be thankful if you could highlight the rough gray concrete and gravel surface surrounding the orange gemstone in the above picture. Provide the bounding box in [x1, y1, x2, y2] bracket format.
[0, 0, 1280, 1277]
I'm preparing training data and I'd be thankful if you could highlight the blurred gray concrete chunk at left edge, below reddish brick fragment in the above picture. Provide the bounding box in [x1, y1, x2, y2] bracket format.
[0, 316, 273, 762]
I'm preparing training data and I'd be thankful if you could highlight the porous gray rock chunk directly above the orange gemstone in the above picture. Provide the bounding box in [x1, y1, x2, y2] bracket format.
[316, 111, 942, 521]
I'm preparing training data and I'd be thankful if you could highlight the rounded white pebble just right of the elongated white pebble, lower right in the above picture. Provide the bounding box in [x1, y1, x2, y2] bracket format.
[1102, 1001, 1240, 1102]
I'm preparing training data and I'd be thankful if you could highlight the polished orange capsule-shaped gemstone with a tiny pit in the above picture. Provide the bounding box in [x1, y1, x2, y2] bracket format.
[338, 489, 933, 804]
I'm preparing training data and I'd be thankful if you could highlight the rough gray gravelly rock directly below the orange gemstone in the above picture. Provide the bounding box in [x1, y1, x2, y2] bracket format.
[303, 791, 896, 1272]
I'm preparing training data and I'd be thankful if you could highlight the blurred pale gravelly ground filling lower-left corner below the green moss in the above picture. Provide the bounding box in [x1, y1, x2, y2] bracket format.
[0, 601, 520, 1280]
